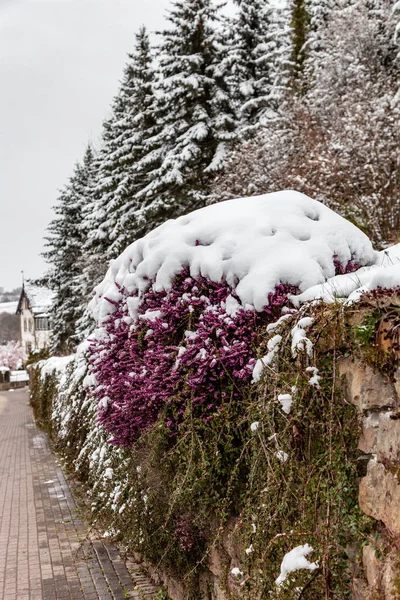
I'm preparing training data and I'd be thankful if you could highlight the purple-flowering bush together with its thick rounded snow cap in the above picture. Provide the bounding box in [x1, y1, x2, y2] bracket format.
[89, 192, 375, 445]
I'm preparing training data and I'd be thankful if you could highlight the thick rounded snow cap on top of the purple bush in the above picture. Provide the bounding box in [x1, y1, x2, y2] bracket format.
[91, 191, 378, 323]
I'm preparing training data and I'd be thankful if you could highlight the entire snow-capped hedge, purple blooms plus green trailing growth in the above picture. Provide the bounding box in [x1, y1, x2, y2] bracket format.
[28, 192, 400, 599]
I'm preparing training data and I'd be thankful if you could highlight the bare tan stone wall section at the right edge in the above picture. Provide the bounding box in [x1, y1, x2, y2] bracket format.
[339, 358, 400, 600]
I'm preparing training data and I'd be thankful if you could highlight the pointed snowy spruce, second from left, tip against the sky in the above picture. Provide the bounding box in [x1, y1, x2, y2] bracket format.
[86, 27, 155, 262]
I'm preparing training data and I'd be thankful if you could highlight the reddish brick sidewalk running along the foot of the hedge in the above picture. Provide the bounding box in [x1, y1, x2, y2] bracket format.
[0, 391, 157, 600]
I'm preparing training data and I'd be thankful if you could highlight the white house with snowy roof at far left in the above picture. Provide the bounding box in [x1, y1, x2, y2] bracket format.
[17, 283, 54, 355]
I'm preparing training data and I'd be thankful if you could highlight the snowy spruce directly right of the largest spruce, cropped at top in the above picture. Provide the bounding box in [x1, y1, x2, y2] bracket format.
[225, 0, 290, 138]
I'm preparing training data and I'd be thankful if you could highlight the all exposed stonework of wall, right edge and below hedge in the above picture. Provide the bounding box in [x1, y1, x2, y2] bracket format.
[135, 358, 400, 600]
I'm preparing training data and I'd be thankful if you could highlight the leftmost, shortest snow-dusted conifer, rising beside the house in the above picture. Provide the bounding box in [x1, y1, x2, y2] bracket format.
[43, 146, 94, 353]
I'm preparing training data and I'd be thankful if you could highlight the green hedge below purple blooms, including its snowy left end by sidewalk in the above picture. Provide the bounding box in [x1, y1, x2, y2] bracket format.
[31, 307, 368, 600]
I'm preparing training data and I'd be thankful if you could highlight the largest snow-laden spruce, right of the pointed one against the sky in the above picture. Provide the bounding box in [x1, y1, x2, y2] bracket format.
[133, 0, 236, 233]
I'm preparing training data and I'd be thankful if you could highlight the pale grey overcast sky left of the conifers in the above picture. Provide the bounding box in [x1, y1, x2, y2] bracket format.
[0, 0, 183, 289]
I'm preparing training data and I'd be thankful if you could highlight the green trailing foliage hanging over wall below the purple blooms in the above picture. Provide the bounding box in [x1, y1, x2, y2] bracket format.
[75, 306, 371, 600]
